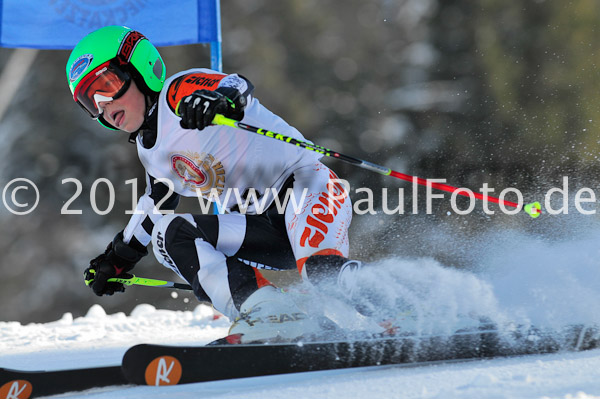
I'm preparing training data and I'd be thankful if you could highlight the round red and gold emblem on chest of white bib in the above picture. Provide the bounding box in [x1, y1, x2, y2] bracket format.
[171, 152, 225, 195]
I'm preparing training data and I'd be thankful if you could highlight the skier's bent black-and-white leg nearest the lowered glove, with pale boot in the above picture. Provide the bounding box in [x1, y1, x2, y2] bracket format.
[153, 214, 318, 342]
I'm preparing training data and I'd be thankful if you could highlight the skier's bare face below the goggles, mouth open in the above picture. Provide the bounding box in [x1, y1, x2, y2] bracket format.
[98, 80, 146, 133]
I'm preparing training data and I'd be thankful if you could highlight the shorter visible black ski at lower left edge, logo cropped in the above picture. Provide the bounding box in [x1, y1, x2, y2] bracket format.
[0, 365, 128, 399]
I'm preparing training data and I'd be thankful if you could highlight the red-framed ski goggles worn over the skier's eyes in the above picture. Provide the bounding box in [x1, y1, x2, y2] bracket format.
[73, 61, 131, 119]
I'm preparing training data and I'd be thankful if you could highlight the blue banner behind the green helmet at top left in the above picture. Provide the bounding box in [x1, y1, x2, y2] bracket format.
[0, 0, 221, 50]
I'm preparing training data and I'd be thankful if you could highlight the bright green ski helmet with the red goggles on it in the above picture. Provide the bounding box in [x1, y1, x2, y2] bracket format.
[66, 25, 166, 130]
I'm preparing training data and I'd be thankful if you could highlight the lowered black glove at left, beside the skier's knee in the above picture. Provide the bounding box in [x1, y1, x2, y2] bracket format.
[83, 232, 148, 296]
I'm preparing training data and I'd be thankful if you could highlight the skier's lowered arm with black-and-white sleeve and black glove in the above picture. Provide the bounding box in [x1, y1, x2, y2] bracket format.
[84, 176, 179, 296]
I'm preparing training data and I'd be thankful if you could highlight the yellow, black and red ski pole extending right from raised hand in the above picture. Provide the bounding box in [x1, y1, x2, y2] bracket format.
[213, 114, 542, 218]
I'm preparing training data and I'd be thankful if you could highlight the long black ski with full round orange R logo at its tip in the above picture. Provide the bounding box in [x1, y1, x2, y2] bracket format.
[123, 326, 600, 386]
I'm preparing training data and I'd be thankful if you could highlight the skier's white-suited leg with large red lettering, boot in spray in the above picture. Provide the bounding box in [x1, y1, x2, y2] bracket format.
[286, 163, 392, 332]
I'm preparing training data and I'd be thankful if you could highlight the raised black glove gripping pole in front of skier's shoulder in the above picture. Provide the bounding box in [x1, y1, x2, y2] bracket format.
[176, 87, 246, 130]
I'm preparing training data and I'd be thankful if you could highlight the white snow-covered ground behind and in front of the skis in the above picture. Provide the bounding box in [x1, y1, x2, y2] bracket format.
[0, 305, 600, 399]
